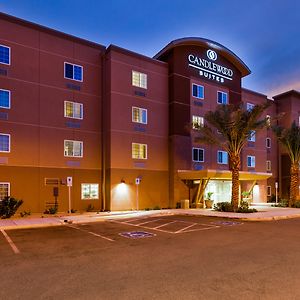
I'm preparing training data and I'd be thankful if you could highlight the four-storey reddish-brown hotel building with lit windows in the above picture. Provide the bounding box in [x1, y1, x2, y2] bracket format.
[0, 13, 300, 212]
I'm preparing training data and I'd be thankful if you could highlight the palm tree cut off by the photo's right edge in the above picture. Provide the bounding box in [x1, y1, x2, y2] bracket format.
[272, 121, 300, 207]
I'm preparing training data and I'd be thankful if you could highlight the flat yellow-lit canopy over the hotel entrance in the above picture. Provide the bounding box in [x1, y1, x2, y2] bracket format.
[177, 169, 272, 180]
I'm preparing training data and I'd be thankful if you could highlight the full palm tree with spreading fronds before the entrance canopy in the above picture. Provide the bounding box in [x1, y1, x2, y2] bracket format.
[196, 103, 269, 211]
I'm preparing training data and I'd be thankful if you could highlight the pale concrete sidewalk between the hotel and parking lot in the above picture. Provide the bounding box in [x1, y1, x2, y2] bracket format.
[0, 204, 300, 230]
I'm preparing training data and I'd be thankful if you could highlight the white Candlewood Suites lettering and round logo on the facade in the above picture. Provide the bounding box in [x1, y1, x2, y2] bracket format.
[188, 49, 233, 83]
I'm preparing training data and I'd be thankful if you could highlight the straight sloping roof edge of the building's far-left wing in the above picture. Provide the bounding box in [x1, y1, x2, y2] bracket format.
[0, 12, 106, 51]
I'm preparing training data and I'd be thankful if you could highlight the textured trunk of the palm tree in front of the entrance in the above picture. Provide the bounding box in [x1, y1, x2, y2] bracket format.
[230, 155, 241, 211]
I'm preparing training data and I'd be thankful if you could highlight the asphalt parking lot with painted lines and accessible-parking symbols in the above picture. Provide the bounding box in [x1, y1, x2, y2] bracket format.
[0, 215, 300, 299]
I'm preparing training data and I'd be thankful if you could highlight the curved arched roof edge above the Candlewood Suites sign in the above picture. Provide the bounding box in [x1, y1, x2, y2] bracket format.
[153, 37, 251, 77]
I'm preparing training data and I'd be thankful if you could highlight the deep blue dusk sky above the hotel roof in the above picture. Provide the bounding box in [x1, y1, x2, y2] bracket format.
[0, 0, 300, 97]
